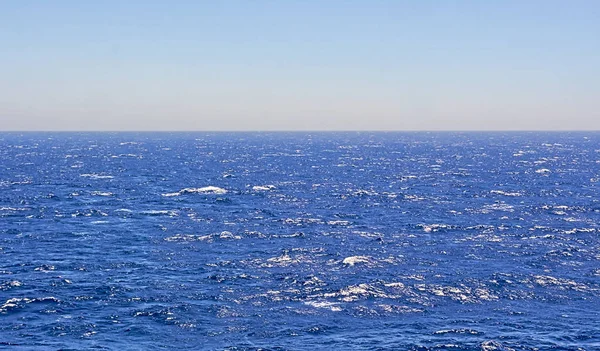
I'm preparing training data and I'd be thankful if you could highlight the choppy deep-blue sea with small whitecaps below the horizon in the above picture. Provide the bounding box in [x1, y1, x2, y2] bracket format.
[0, 132, 600, 351]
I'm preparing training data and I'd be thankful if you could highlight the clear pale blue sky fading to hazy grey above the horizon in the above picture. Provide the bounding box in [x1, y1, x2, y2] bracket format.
[0, 0, 600, 131]
